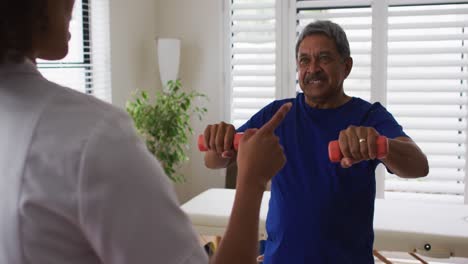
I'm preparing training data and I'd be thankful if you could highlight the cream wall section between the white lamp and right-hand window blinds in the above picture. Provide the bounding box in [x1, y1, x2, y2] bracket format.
[156, 0, 225, 201]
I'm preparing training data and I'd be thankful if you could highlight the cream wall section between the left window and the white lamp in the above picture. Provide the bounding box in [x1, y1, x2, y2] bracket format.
[109, 0, 159, 107]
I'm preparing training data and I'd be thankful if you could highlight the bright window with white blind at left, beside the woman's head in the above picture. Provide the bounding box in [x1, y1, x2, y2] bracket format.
[38, 0, 111, 101]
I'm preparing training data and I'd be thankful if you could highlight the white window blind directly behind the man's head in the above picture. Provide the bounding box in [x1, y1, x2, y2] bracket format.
[293, 0, 372, 100]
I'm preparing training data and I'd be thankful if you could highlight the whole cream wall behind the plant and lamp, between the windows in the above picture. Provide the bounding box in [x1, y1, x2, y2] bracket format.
[110, 0, 225, 202]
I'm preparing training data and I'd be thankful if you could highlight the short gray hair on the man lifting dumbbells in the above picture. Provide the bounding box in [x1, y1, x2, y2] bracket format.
[296, 20, 351, 59]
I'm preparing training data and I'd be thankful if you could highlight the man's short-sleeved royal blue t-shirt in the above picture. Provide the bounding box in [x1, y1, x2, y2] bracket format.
[238, 93, 406, 264]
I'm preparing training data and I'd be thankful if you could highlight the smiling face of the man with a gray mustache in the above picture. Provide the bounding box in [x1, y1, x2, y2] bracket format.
[296, 34, 352, 103]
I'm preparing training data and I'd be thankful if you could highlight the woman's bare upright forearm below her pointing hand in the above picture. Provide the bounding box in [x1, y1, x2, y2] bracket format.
[211, 183, 264, 264]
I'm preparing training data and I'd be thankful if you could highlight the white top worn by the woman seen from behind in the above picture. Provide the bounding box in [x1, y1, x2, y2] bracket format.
[0, 62, 208, 264]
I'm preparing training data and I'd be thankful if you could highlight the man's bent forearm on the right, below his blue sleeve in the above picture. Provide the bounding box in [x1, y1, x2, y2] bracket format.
[382, 137, 429, 178]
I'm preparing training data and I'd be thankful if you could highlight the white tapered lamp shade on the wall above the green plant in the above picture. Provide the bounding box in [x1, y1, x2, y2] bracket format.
[156, 38, 180, 87]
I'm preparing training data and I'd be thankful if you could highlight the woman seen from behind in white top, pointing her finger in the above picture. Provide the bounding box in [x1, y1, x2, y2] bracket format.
[0, 0, 290, 264]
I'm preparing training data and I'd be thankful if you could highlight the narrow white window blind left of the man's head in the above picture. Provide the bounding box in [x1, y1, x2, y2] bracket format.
[229, 0, 276, 127]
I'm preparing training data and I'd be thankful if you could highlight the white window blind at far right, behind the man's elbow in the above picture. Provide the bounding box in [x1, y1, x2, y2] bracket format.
[385, 1, 468, 203]
